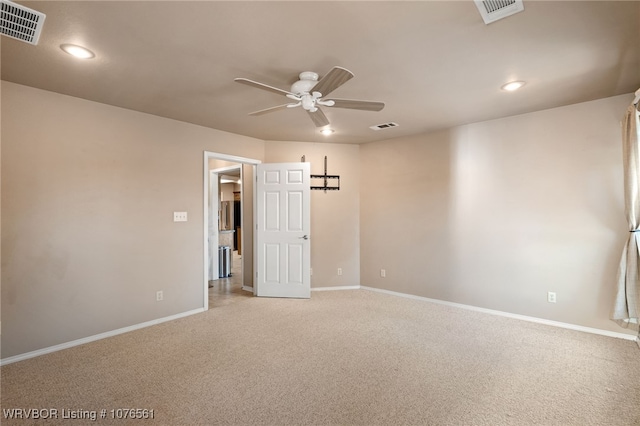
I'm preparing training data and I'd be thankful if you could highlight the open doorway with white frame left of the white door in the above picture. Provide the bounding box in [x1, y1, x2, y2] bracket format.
[203, 152, 260, 309]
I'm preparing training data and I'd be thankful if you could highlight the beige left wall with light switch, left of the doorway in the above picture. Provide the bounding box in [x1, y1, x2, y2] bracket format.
[2, 82, 264, 358]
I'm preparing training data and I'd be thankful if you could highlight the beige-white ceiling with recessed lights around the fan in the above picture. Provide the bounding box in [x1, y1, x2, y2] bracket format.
[0, 0, 640, 143]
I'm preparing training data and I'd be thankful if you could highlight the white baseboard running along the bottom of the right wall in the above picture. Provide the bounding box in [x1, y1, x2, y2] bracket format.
[360, 286, 640, 346]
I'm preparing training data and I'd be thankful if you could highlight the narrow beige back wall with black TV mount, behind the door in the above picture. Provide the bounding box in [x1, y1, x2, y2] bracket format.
[265, 141, 360, 288]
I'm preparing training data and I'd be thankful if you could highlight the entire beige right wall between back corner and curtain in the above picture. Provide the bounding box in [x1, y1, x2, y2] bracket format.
[360, 95, 632, 332]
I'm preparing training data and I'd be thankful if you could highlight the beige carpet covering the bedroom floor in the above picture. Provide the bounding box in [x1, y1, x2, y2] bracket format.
[0, 290, 640, 426]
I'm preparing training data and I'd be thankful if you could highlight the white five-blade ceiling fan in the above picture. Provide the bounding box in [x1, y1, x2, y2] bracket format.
[234, 67, 384, 127]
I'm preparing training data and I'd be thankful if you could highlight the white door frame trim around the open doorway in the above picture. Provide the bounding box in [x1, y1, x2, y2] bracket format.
[202, 151, 262, 310]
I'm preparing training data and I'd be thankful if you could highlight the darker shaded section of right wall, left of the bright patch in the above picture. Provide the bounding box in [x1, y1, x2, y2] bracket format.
[360, 131, 455, 299]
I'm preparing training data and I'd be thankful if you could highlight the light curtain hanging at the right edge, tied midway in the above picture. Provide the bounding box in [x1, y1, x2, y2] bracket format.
[611, 100, 640, 330]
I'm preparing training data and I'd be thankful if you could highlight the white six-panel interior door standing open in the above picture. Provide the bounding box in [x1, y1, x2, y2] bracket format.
[256, 163, 311, 298]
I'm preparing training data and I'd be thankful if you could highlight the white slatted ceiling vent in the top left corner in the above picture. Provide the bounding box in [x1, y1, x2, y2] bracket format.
[0, 0, 46, 44]
